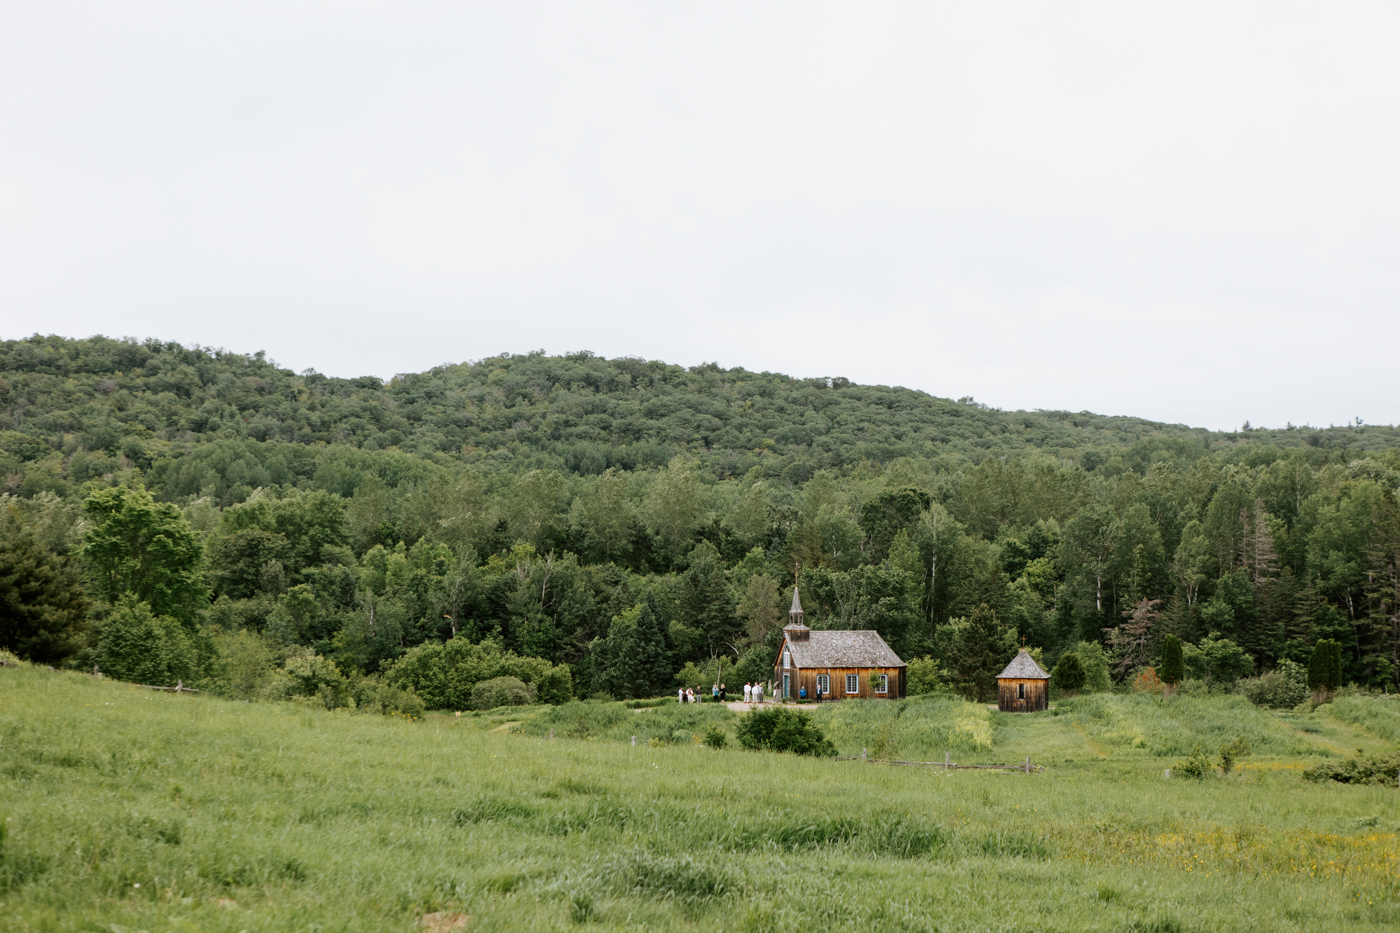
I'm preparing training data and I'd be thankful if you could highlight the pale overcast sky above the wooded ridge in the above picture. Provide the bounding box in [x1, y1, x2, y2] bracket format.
[0, 0, 1400, 429]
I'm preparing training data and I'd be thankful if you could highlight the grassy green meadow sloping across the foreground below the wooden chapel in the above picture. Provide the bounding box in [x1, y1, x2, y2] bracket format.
[0, 667, 1400, 933]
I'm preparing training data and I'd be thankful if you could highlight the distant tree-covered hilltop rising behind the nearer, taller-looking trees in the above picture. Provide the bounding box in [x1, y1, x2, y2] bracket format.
[0, 336, 1400, 482]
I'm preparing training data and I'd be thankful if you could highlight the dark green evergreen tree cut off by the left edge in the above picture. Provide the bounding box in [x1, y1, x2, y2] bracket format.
[0, 516, 88, 664]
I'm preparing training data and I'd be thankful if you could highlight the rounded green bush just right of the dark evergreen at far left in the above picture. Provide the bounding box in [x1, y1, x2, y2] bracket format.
[97, 594, 200, 686]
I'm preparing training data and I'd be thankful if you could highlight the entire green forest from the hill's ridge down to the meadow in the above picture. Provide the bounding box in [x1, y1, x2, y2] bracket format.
[0, 336, 1400, 706]
